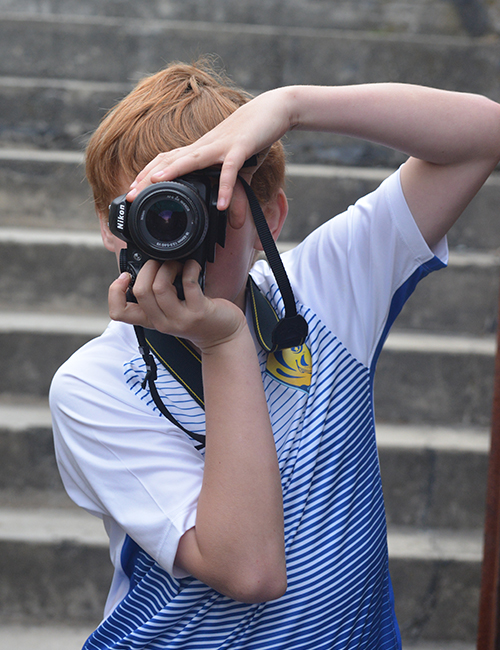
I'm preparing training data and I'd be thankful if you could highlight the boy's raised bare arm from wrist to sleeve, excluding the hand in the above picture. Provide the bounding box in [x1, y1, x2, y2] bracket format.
[297, 84, 500, 246]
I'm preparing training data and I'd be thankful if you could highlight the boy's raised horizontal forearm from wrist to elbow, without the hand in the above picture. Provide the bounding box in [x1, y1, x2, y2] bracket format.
[282, 83, 500, 164]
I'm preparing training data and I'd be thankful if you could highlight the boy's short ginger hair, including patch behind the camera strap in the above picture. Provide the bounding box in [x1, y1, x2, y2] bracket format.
[86, 58, 285, 213]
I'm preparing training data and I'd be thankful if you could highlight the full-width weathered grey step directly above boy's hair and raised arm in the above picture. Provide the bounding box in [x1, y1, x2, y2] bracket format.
[0, 13, 500, 99]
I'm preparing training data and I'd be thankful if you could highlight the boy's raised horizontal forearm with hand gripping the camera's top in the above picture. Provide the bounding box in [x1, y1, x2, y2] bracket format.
[128, 83, 500, 210]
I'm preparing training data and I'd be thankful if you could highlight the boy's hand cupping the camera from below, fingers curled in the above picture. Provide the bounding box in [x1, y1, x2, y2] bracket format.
[108, 260, 247, 353]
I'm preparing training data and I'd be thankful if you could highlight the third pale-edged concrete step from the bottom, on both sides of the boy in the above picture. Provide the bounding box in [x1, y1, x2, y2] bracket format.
[0, 398, 489, 529]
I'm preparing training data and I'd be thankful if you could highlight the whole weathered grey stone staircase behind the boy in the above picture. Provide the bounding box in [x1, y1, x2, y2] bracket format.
[0, 0, 500, 650]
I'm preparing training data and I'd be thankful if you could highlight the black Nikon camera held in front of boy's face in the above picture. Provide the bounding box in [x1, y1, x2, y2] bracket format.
[109, 171, 226, 298]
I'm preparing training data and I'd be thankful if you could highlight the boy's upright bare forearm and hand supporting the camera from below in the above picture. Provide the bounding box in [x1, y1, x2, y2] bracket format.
[110, 260, 286, 602]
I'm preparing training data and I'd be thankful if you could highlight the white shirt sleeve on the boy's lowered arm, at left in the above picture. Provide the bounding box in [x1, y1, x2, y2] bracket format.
[50, 322, 204, 577]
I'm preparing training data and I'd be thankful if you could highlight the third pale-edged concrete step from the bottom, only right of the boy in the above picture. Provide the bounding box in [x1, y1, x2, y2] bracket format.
[377, 422, 490, 529]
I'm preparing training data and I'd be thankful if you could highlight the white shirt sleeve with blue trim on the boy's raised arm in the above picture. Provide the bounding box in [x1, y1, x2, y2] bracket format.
[274, 170, 448, 366]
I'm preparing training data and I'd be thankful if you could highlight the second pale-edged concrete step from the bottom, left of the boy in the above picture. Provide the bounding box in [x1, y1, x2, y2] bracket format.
[0, 508, 112, 625]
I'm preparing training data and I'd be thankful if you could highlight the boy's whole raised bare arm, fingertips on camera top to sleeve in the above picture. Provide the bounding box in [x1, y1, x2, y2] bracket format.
[129, 84, 500, 246]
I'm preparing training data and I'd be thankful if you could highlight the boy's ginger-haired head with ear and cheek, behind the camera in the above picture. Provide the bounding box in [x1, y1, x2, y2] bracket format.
[86, 59, 286, 300]
